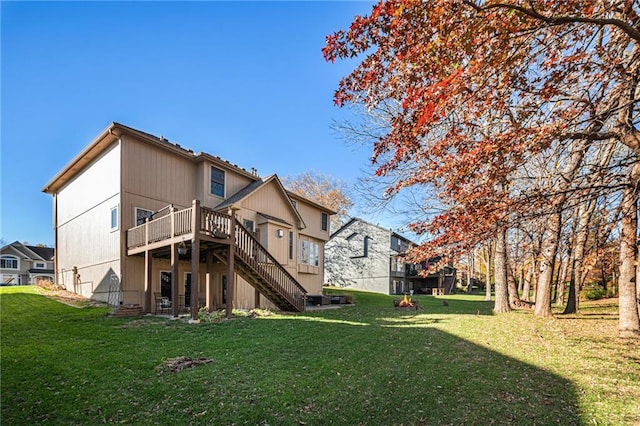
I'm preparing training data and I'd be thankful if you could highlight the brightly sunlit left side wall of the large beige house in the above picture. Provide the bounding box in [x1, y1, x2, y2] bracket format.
[56, 143, 122, 301]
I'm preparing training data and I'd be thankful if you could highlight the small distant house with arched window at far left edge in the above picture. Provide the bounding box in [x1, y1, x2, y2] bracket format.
[0, 241, 54, 285]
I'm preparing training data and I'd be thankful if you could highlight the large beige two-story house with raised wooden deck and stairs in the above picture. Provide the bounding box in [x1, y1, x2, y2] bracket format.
[43, 123, 335, 319]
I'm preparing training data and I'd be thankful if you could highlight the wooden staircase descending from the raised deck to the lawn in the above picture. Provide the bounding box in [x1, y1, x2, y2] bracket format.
[221, 218, 307, 312]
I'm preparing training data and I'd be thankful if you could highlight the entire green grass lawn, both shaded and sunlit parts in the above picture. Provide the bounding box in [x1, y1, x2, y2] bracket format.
[0, 287, 640, 425]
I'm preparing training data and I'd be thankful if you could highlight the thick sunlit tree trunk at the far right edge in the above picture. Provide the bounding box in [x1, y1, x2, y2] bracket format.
[618, 171, 640, 337]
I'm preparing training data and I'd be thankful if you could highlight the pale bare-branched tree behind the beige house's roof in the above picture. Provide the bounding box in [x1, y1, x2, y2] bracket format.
[282, 171, 353, 231]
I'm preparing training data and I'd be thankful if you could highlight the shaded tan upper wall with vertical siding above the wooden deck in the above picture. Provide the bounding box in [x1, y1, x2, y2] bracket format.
[122, 136, 197, 229]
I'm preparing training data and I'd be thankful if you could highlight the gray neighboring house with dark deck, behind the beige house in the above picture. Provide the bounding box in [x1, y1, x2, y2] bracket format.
[325, 218, 455, 294]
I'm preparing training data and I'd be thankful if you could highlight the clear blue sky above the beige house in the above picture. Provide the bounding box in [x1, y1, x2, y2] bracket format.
[0, 1, 404, 245]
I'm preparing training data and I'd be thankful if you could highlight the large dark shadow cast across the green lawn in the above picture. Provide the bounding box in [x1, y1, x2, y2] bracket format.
[0, 288, 585, 425]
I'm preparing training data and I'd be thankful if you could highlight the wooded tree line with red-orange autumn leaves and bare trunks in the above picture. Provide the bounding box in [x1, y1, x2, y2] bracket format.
[323, 0, 640, 336]
